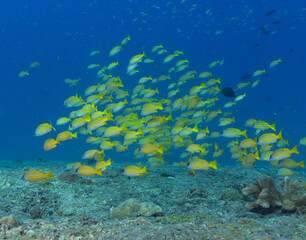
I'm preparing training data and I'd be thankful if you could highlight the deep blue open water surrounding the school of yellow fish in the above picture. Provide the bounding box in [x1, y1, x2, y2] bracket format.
[0, 0, 306, 167]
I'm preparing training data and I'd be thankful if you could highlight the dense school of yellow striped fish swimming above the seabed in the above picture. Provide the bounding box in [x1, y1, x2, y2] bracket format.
[20, 36, 306, 181]
